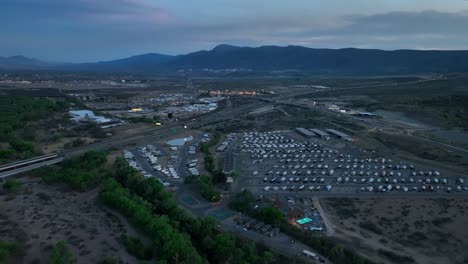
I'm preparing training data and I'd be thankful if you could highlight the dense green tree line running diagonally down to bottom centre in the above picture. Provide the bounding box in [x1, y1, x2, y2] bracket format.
[109, 158, 273, 263]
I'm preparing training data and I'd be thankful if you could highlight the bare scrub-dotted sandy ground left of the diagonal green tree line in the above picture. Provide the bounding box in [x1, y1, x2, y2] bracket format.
[0, 178, 141, 263]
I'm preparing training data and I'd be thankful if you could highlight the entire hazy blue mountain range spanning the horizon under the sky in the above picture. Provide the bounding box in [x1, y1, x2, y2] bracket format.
[0, 44, 468, 74]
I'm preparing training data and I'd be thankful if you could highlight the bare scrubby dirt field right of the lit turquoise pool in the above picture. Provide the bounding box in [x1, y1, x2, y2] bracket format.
[318, 198, 468, 264]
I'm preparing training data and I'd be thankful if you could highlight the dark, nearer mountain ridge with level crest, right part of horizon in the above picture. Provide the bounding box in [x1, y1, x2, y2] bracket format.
[165, 45, 468, 74]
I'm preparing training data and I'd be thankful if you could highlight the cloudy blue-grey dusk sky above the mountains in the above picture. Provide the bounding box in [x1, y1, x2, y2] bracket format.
[0, 0, 468, 62]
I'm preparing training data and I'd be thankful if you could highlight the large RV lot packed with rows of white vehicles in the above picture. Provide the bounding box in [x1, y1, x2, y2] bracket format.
[230, 131, 468, 195]
